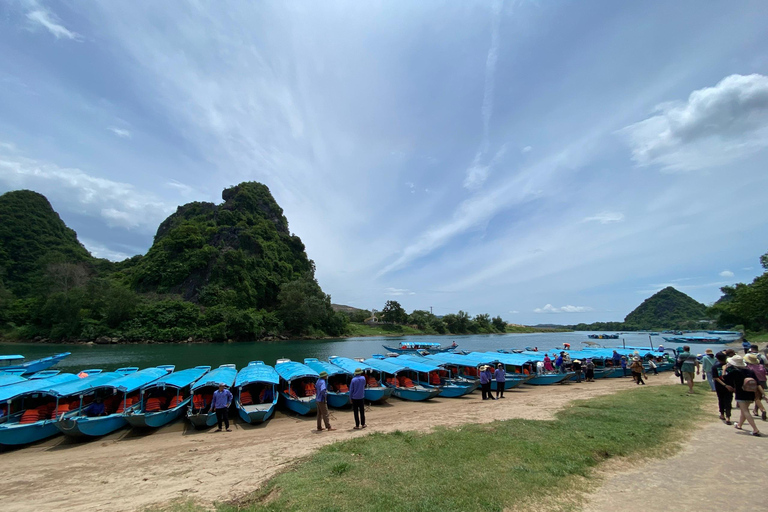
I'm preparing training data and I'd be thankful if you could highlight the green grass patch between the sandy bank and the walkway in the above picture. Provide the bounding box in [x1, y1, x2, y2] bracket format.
[201, 384, 707, 512]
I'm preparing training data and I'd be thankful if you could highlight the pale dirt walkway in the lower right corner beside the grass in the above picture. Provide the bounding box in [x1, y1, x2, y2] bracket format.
[584, 415, 768, 512]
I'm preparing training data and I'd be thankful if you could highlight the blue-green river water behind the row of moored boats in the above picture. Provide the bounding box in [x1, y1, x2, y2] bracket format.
[0, 332, 744, 371]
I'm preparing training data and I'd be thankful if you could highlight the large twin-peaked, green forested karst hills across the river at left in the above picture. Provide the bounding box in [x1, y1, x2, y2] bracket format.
[0, 182, 347, 341]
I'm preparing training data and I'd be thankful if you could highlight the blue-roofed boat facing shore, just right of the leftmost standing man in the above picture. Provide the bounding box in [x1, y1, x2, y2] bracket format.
[233, 361, 280, 423]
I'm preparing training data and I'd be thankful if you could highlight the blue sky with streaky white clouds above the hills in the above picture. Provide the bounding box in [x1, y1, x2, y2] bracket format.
[0, 0, 768, 324]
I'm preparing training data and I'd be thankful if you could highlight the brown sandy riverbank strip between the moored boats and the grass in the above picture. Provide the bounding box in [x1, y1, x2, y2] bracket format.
[0, 373, 675, 512]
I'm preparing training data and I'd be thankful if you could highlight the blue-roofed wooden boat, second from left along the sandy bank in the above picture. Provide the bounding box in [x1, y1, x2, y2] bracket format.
[56, 365, 173, 437]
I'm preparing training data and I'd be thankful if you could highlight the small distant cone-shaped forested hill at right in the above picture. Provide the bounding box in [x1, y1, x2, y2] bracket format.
[624, 286, 707, 329]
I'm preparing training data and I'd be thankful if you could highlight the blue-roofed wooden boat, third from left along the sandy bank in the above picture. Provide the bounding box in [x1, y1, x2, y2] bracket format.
[125, 366, 211, 428]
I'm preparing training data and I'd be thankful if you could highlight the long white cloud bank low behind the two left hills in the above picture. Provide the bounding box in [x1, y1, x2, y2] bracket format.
[0, 145, 176, 232]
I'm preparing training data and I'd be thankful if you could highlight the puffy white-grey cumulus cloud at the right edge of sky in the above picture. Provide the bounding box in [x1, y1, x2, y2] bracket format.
[622, 74, 768, 171]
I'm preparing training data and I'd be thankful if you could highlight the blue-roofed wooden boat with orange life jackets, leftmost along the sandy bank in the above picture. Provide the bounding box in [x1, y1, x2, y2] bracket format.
[0, 370, 130, 445]
